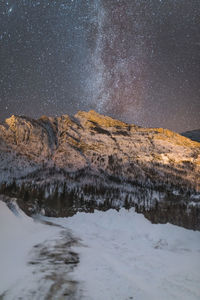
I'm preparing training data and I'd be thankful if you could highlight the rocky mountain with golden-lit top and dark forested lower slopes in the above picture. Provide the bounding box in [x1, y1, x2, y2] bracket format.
[0, 111, 200, 229]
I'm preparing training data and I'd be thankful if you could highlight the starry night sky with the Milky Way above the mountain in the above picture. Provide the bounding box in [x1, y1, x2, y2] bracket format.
[0, 0, 200, 132]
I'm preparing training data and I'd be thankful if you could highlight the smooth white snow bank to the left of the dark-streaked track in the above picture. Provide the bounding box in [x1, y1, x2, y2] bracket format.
[0, 201, 58, 295]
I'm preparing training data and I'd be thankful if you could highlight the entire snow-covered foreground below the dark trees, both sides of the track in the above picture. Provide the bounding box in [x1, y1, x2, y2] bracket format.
[0, 201, 200, 300]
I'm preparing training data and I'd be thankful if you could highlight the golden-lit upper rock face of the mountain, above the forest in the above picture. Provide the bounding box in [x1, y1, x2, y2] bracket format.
[0, 111, 200, 187]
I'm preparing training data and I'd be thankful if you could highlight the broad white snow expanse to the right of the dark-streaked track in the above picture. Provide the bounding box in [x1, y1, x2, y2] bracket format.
[45, 209, 200, 300]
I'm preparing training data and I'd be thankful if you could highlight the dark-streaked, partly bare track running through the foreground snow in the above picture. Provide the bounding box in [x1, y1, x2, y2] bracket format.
[3, 230, 79, 300]
